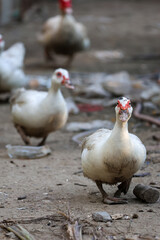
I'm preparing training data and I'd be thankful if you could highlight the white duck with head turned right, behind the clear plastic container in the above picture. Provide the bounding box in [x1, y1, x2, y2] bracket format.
[10, 68, 74, 146]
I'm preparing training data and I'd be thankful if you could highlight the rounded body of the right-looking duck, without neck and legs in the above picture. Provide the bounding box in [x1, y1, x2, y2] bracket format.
[12, 91, 68, 137]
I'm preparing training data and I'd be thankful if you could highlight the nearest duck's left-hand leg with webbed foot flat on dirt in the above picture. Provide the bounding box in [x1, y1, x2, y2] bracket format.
[96, 181, 127, 204]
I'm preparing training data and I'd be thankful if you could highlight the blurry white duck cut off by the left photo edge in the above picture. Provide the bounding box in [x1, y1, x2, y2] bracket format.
[0, 35, 27, 93]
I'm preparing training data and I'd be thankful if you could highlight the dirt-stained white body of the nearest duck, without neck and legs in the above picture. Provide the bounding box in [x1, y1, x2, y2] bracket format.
[81, 124, 146, 184]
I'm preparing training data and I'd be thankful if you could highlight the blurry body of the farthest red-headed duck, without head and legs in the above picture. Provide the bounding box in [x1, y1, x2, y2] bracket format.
[38, 14, 90, 55]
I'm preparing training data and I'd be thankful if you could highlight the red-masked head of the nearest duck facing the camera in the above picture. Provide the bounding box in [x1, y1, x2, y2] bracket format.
[115, 97, 133, 122]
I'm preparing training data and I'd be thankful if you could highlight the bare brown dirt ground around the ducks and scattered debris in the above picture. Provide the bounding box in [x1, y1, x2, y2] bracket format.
[0, 0, 160, 240]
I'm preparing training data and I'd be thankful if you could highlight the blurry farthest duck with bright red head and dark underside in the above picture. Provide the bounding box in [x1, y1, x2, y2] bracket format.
[37, 0, 90, 66]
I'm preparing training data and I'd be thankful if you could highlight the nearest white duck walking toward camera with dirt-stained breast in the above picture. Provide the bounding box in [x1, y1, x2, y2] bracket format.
[81, 97, 146, 204]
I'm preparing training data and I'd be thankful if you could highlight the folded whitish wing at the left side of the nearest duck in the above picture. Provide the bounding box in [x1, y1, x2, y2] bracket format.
[82, 128, 111, 151]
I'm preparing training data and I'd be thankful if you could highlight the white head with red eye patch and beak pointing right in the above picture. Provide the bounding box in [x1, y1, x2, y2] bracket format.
[52, 68, 74, 89]
